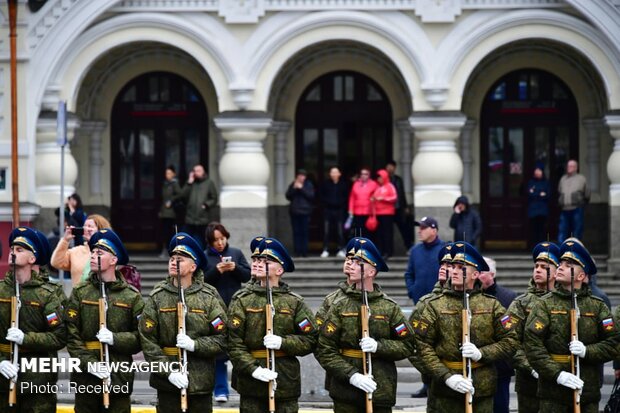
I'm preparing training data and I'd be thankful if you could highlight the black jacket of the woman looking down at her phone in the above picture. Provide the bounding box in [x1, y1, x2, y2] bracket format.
[204, 245, 250, 305]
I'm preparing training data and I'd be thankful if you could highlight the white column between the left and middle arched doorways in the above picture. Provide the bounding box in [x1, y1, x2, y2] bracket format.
[214, 111, 272, 249]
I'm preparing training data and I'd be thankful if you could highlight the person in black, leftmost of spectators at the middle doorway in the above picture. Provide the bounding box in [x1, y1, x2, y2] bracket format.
[286, 169, 314, 257]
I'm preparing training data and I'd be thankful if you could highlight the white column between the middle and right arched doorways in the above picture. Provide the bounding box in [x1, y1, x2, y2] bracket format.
[409, 112, 466, 207]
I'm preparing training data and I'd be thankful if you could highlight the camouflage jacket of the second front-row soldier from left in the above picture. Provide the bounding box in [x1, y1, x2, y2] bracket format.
[65, 271, 144, 391]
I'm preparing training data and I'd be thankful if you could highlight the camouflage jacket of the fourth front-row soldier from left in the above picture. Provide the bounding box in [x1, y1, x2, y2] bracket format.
[228, 281, 318, 399]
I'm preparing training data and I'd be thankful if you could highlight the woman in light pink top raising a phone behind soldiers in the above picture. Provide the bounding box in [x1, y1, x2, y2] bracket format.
[51, 214, 112, 286]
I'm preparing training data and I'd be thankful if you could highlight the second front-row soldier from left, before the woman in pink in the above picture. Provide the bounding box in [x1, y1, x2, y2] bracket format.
[65, 229, 144, 413]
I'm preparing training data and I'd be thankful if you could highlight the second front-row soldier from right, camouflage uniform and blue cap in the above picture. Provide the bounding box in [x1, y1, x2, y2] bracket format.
[413, 241, 518, 413]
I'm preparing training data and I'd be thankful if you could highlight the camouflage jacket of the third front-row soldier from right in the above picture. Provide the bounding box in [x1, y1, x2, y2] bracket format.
[316, 286, 414, 406]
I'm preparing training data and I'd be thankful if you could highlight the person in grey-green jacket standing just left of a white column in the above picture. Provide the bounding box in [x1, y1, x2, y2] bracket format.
[183, 165, 218, 249]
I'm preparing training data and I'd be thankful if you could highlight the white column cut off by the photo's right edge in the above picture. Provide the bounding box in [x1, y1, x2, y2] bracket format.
[605, 114, 620, 273]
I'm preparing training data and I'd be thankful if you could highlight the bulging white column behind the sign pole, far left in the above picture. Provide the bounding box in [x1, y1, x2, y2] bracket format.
[35, 111, 79, 208]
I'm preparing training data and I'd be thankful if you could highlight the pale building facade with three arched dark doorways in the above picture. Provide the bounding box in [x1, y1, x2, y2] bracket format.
[0, 0, 620, 265]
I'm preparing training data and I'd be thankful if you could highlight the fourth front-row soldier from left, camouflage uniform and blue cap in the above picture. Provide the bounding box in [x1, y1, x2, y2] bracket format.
[228, 238, 318, 413]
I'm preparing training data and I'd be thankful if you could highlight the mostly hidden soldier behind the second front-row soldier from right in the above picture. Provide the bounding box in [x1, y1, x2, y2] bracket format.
[409, 243, 452, 411]
